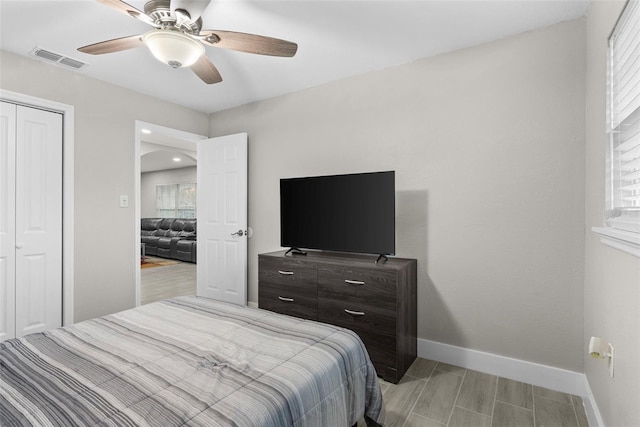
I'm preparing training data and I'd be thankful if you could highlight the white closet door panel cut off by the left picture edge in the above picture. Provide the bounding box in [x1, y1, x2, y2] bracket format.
[0, 102, 16, 341]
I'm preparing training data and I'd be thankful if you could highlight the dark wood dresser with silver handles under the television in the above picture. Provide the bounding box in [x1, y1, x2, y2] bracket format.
[258, 251, 417, 383]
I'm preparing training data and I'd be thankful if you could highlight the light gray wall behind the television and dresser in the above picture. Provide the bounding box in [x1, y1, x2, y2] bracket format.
[209, 19, 585, 372]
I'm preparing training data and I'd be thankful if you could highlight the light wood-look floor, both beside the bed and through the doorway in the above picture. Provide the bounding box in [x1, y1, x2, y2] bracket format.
[141, 262, 589, 427]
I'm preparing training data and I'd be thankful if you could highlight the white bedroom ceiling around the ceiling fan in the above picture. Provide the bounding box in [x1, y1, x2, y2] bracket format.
[0, 0, 589, 113]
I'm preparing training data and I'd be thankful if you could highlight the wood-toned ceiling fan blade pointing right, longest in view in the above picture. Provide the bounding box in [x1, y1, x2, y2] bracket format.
[199, 30, 298, 57]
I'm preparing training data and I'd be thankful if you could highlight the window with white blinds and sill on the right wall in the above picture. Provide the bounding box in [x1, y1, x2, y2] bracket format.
[594, 0, 640, 256]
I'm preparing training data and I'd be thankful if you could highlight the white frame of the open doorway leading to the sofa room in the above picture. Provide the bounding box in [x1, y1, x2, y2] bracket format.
[133, 120, 208, 307]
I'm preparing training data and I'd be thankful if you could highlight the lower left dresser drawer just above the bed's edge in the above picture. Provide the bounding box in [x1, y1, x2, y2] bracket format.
[258, 281, 318, 320]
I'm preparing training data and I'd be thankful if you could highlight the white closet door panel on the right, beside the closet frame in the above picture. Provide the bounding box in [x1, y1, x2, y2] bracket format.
[15, 106, 62, 337]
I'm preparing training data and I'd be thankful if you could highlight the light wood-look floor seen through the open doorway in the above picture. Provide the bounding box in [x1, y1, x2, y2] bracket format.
[140, 256, 196, 304]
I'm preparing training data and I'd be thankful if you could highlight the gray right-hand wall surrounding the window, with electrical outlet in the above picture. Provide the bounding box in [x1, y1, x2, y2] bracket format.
[583, 1, 640, 426]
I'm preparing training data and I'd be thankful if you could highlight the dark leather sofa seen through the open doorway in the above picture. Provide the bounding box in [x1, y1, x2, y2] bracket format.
[140, 218, 197, 262]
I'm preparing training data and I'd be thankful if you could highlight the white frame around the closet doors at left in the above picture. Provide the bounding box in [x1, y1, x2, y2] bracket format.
[0, 89, 75, 326]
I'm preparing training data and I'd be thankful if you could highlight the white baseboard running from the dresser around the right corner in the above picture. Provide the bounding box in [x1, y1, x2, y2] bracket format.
[418, 338, 604, 427]
